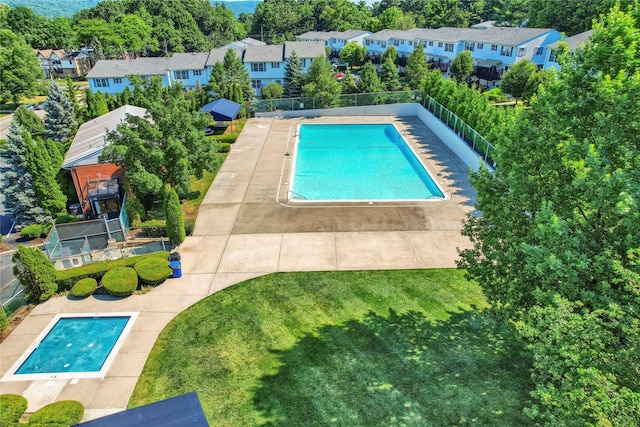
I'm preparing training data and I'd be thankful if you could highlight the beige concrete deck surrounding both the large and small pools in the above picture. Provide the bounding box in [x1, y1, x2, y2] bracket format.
[0, 116, 475, 420]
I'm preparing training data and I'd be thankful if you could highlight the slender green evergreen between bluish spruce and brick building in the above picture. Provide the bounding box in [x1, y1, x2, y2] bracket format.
[22, 130, 67, 217]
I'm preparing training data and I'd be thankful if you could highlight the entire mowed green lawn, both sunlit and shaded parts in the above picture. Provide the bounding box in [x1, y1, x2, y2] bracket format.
[129, 269, 533, 426]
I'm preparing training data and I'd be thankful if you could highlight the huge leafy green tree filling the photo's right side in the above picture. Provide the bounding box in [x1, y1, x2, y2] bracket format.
[459, 8, 640, 426]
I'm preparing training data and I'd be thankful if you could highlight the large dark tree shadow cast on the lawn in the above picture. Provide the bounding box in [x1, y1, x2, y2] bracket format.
[254, 310, 534, 426]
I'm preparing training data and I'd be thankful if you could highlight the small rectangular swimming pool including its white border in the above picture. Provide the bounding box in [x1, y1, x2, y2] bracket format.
[5, 313, 137, 380]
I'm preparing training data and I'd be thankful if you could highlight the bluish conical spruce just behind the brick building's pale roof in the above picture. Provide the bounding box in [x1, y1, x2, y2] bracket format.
[44, 82, 78, 144]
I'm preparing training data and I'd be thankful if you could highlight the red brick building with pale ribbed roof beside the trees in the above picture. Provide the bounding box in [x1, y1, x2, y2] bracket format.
[61, 105, 147, 219]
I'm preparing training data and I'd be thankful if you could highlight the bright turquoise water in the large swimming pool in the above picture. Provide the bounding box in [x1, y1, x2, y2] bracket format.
[290, 124, 444, 201]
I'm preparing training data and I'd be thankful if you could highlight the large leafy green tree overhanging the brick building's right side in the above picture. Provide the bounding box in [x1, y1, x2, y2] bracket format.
[101, 78, 217, 209]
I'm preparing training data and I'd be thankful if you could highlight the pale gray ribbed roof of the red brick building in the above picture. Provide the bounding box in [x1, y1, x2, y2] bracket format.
[62, 105, 147, 169]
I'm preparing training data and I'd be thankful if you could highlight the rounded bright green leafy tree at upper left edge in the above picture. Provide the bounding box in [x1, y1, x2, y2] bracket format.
[0, 29, 43, 105]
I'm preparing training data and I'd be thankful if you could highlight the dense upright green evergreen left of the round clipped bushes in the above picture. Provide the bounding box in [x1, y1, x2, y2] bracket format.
[11, 245, 58, 302]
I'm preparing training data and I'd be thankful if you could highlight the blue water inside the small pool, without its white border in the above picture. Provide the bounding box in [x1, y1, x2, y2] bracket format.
[15, 316, 130, 374]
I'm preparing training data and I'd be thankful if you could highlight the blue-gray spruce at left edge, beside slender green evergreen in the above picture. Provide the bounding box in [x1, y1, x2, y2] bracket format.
[0, 120, 47, 225]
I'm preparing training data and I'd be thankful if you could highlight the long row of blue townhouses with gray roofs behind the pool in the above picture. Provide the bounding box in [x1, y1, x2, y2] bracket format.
[86, 25, 590, 96]
